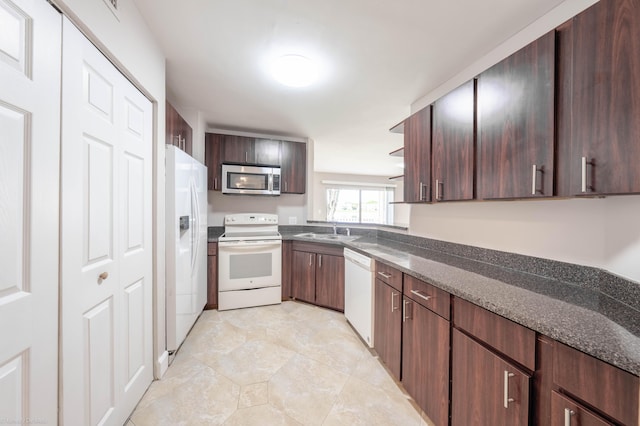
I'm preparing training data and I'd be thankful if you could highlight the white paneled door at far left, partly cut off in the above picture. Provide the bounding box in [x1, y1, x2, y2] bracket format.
[0, 0, 61, 424]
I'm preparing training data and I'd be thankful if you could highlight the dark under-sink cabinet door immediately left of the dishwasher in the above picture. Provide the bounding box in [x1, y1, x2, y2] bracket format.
[316, 254, 344, 311]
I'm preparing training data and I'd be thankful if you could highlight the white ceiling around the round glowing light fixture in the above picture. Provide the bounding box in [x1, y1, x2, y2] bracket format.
[135, 0, 562, 176]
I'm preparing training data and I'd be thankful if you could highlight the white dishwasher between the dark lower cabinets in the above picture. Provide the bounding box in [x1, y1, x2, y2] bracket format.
[344, 248, 375, 348]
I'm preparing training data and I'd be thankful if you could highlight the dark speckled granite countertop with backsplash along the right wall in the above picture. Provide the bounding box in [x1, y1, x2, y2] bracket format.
[281, 227, 640, 376]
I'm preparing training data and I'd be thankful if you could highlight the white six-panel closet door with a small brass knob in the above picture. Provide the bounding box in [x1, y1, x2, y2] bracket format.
[61, 17, 153, 426]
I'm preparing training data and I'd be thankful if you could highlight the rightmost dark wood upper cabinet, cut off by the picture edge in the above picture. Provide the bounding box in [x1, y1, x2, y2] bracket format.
[556, 0, 640, 196]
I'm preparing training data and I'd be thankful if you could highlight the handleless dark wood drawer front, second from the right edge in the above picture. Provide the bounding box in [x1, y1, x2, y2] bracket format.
[453, 297, 536, 371]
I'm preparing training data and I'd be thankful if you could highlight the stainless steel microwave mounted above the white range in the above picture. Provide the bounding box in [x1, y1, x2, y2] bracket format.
[222, 164, 280, 195]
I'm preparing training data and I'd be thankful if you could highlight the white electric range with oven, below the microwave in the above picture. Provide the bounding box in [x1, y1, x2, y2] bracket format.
[218, 213, 282, 311]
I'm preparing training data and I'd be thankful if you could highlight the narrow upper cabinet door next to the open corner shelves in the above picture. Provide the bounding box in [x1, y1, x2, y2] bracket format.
[404, 106, 431, 203]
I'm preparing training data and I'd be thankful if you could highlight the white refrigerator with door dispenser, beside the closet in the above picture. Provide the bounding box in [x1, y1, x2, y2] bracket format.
[165, 145, 207, 353]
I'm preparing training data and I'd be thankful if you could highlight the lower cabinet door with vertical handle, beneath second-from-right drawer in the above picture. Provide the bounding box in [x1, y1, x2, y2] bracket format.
[451, 329, 530, 426]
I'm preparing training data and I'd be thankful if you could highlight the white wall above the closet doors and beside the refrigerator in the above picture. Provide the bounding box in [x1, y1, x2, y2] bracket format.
[53, 0, 168, 377]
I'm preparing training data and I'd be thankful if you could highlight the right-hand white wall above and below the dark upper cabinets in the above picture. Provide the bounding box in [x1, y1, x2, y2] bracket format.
[409, 0, 640, 282]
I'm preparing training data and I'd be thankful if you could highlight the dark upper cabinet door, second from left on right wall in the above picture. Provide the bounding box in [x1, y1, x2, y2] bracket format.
[431, 80, 475, 201]
